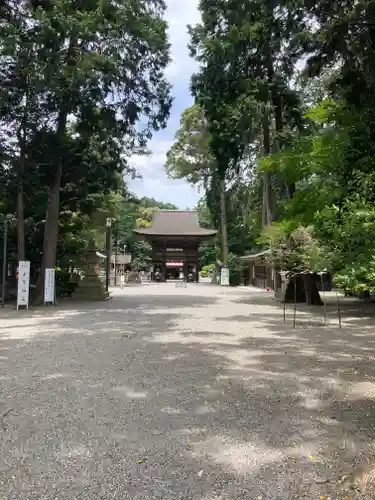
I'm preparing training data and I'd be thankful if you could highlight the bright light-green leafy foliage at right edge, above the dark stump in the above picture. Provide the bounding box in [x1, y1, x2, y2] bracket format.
[260, 83, 375, 291]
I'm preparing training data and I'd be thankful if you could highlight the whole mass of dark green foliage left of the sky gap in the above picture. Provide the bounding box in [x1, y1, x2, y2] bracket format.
[0, 0, 171, 290]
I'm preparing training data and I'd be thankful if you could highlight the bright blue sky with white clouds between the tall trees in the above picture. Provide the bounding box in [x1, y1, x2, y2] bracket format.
[129, 0, 200, 208]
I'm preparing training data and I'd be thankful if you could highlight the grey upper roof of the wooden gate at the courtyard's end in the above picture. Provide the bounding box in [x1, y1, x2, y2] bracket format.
[133, 210, 217, 236]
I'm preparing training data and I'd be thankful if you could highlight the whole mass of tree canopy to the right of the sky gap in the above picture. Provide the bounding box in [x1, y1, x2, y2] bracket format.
[166, 0, 375, 293]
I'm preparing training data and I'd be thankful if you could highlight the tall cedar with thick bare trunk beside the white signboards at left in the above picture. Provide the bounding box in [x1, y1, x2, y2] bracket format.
[0, 0, 171, 298]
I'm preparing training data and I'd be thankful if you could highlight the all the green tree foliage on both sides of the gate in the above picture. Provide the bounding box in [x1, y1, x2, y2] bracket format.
[0, 0, 375, 292]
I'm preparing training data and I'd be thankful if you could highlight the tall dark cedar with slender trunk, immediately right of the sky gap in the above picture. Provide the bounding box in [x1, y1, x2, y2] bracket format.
[190, 0, 301, 270]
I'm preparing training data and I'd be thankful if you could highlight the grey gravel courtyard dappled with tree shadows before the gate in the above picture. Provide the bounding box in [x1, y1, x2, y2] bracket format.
[0, 284, 375, 500]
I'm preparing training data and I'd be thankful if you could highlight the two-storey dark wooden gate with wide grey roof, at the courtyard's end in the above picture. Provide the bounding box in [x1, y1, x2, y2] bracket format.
[133, 210, 217, 281]
